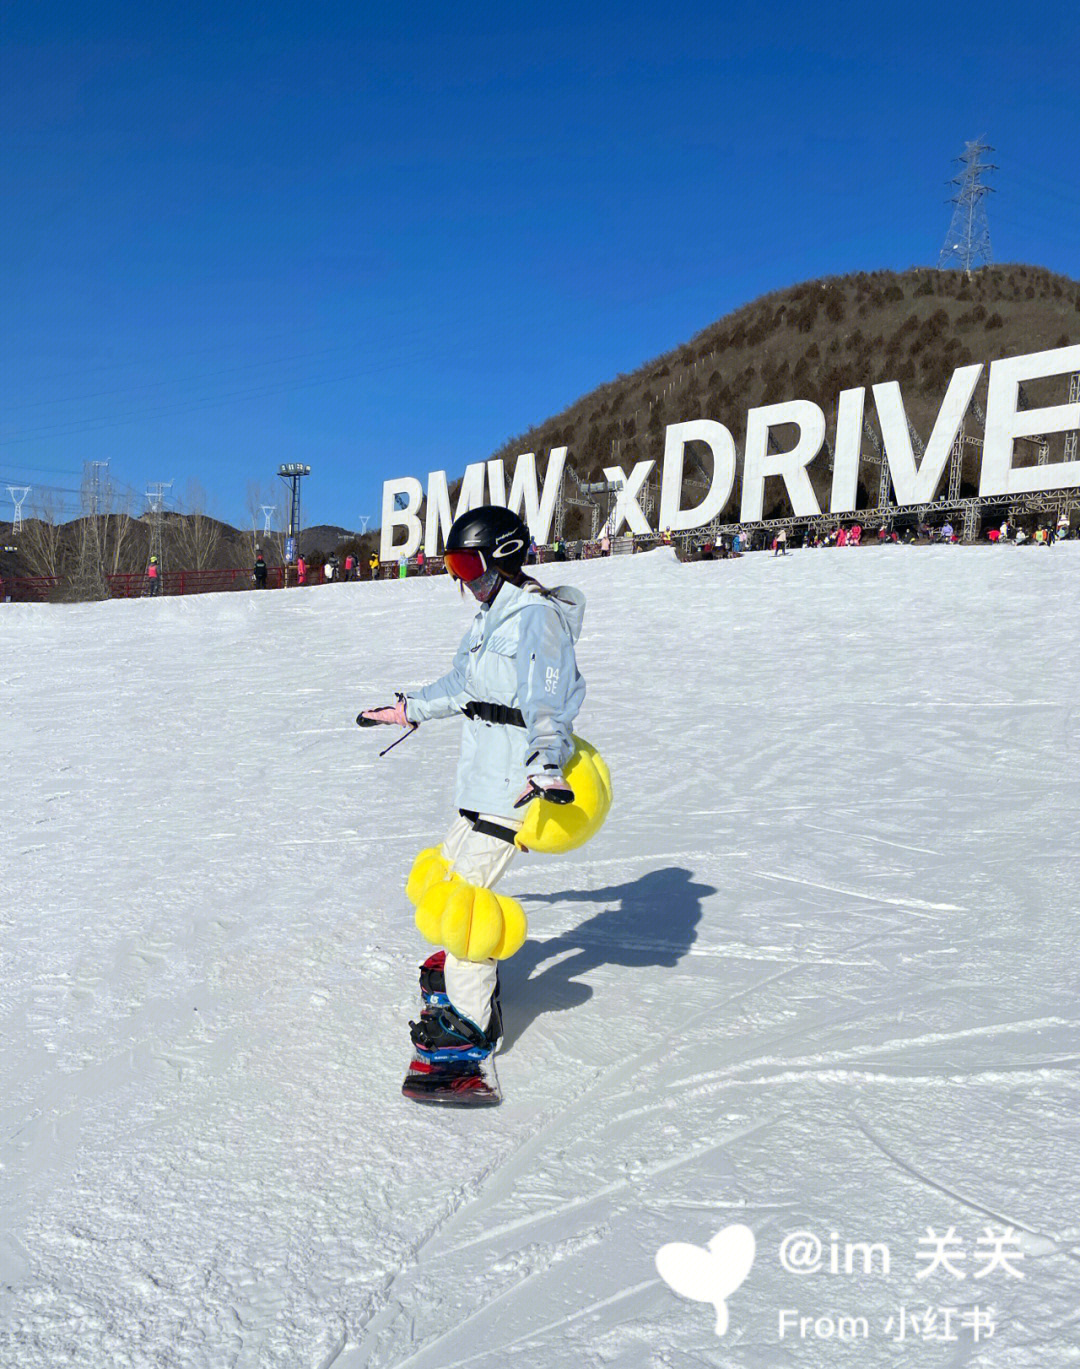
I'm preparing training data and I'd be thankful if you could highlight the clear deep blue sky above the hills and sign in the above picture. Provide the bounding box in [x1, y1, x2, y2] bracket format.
[0, 0, 1080, 527]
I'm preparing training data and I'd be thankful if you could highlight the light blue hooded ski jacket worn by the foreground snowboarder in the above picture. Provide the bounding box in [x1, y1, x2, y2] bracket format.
[405, 580, 584, 819]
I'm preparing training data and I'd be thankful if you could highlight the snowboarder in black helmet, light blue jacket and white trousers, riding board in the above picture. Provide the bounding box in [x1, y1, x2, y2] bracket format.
[357, 505, 584, 1102]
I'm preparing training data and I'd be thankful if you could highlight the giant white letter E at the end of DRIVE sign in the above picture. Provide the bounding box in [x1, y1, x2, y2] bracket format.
[979, 344, 1080, 496]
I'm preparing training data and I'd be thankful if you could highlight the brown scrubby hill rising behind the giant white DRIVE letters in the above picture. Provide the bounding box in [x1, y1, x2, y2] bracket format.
[493, 266, 1080, 538]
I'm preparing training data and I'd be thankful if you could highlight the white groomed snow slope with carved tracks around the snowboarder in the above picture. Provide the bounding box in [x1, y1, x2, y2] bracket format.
[0, 542, 1080, 1369]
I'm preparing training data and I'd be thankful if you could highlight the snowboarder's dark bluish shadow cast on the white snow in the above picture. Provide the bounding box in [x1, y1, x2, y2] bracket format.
[500, 867, 716, 1051]
